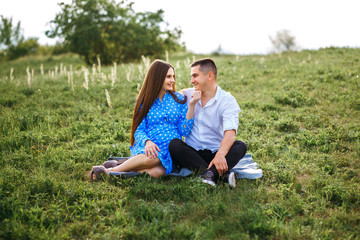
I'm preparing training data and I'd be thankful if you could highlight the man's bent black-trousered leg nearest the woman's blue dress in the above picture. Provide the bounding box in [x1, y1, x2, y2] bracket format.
[169, 138, 209, 170]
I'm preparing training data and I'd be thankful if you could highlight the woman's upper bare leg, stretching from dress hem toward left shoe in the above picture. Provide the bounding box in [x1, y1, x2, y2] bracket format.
[106, 154, 162, 173]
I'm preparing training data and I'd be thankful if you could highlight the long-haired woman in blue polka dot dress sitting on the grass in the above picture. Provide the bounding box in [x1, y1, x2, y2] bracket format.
[90, 60, 201, 179]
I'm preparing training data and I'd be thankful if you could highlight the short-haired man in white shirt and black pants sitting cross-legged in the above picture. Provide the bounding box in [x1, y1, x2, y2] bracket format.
[169, 58, 247, 188]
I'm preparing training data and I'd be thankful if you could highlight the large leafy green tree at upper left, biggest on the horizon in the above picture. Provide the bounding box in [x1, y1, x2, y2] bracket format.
[46, 0, 181, 64]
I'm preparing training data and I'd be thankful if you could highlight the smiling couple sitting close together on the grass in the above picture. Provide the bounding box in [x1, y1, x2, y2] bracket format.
[90, 58, 246, 187]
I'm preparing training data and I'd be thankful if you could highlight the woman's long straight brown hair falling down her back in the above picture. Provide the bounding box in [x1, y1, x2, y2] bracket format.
[130, 60, 186, 146]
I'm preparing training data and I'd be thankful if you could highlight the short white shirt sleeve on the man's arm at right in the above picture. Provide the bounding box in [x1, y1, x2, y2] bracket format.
[222, 96, 240, 133]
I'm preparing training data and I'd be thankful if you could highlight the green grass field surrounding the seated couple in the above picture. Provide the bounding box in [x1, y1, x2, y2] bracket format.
[0, 48, 360, 239]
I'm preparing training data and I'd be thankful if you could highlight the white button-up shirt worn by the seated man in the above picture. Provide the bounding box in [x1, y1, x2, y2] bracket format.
[184, 86, 240, 152]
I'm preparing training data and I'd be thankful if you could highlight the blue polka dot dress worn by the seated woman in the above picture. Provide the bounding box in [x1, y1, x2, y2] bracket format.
[130, 92, 194, 174]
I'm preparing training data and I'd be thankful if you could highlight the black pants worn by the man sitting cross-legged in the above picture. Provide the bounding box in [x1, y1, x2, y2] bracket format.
[169, 139, 247, 180]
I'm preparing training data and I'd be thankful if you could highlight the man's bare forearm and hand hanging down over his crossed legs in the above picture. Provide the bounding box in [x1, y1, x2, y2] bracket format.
[208, 129, 236, 176]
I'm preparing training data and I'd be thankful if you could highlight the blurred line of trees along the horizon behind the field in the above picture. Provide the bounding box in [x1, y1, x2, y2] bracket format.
[0, 0, 297, 65]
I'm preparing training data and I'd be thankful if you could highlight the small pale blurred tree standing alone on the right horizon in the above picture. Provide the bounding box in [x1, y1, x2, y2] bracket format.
[269, 29, 297, 53]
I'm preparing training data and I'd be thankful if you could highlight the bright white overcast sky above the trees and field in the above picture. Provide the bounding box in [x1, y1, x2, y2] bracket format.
[0, 0, 360, 55]
